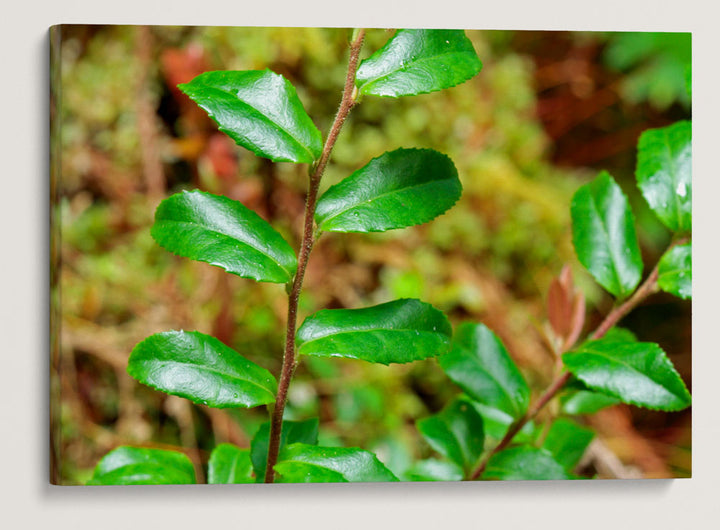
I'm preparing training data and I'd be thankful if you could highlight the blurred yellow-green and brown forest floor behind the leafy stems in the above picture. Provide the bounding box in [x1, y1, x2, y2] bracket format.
[50, 25, 692, 484]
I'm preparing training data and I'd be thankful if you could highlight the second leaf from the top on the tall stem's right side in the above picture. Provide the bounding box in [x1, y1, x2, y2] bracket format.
[315, 149, 462, 232]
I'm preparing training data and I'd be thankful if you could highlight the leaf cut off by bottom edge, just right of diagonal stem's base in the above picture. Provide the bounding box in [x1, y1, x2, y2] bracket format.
[482, 446, 570, 480]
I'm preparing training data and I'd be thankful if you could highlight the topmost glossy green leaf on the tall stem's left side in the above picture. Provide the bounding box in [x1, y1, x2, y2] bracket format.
[178, 70, 322, 163]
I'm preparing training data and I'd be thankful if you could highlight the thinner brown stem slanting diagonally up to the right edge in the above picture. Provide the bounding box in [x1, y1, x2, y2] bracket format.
[470, 238, 687, 480]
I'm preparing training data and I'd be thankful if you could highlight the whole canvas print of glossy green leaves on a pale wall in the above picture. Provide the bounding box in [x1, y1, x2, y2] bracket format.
[50, 25, 692, 485]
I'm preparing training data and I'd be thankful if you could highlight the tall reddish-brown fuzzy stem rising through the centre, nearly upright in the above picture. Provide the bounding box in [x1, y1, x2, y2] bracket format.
[265, 29, 365, 483]
